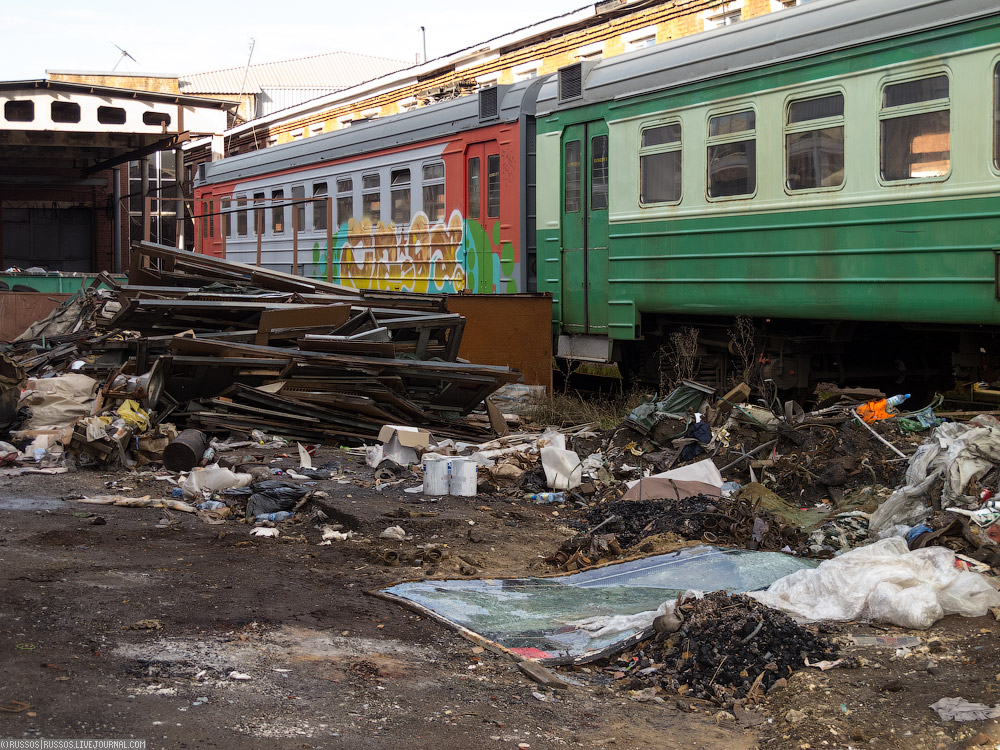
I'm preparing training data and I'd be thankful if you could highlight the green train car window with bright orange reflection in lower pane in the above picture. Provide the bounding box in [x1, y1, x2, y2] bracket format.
[879, 75, 951, 180]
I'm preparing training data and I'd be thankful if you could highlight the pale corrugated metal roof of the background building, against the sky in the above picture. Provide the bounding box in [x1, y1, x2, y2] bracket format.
[178, 52, 412, 94]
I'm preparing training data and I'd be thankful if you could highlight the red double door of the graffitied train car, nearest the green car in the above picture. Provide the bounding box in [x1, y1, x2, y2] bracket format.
[465, 141, 500, 294]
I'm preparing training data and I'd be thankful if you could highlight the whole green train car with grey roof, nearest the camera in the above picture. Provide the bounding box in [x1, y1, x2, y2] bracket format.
[536, 0, 1000, 388]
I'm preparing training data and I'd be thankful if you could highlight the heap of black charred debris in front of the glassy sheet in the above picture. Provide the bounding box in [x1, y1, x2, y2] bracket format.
[618, 591, 837, 708]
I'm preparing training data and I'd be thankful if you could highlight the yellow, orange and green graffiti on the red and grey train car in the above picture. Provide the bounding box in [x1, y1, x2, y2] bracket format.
[312, 210, 517, 294]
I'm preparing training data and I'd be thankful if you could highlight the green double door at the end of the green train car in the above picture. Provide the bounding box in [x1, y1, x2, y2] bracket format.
[560, 120, 608, 335]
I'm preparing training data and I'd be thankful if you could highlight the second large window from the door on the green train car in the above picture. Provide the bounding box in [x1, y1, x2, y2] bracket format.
[708, 109, 757, 198]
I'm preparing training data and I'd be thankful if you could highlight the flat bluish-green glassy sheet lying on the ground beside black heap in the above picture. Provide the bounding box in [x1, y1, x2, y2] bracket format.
[382, 546, 815, 662]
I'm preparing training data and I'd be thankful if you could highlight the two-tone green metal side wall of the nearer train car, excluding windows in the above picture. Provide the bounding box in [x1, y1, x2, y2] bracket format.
[538, 11, 1000, 340]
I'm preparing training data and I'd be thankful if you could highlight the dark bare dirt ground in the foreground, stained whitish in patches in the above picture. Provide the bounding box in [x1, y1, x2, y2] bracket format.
[0, 451, 1000, 750]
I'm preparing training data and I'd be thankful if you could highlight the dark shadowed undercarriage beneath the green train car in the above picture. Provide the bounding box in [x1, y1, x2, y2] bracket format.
[560, 315, 1000, 401]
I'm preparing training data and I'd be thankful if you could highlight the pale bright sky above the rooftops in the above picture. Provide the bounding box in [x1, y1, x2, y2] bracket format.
[0, 0, 588, 81]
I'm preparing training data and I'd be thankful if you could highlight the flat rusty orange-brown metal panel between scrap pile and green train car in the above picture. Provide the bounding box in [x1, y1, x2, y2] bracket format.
[448, 294, 552, 392]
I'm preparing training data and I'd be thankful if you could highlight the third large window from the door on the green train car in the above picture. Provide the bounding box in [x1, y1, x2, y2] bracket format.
[785, 94, 844, 190]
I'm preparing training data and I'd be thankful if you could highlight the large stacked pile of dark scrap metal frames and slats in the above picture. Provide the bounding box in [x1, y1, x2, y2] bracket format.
[0, 243, 520, 459]
